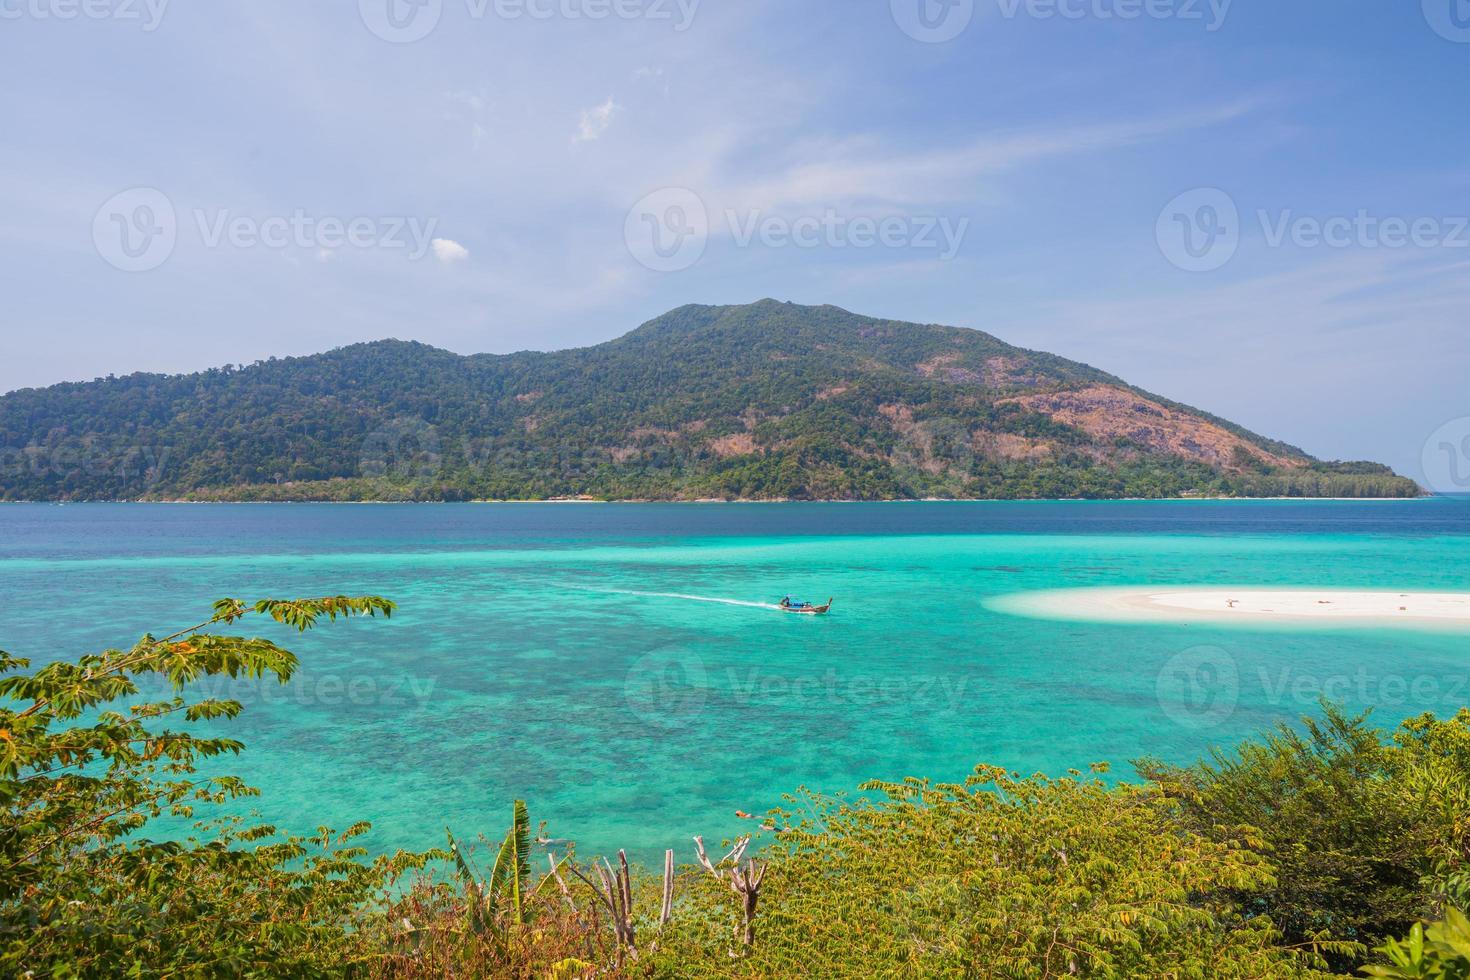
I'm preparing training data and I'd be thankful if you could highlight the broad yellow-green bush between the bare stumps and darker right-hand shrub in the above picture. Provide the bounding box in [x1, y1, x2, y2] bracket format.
[659, 767, 1340, 977]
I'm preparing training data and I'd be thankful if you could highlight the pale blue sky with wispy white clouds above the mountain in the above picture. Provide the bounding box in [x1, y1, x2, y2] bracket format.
[0, 0, 1470, 489]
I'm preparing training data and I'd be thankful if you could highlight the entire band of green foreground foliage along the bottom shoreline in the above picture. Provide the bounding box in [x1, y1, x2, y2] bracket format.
[0, 597, 1470, 980]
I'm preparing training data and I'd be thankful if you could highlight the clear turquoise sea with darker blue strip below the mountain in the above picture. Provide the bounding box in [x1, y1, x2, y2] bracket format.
[0, 500, 1470, 860]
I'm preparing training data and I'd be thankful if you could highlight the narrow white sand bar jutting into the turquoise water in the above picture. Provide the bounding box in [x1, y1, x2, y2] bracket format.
[986, 586, 1470, 627]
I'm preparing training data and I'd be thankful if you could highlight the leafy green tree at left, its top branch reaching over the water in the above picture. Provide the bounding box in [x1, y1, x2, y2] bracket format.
[0, 597, 425, 977]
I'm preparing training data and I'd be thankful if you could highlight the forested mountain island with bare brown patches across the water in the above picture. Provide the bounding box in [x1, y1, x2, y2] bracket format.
[0, 300, 1420, 500]
